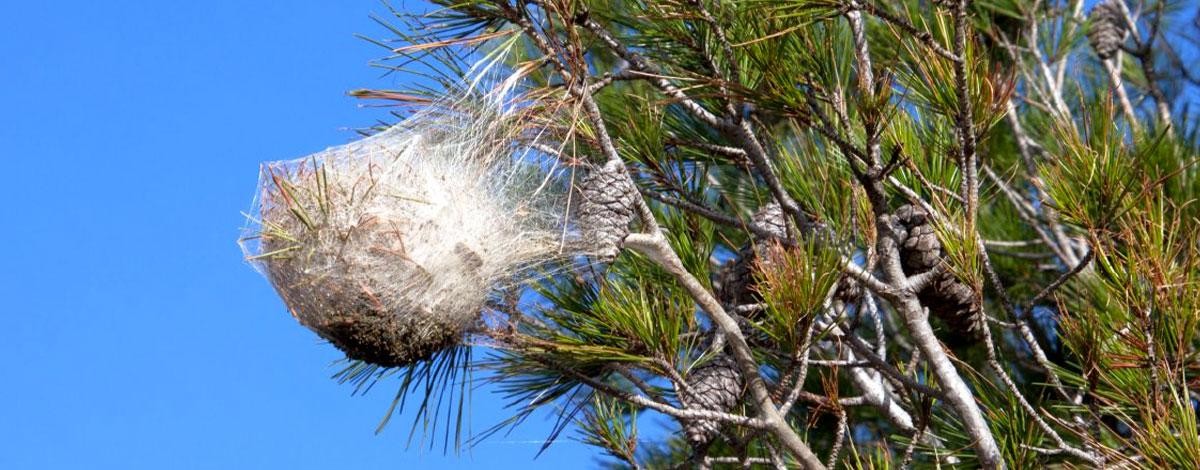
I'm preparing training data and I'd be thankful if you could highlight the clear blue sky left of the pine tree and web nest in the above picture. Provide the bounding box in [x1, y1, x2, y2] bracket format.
[0, 0, 594, 470]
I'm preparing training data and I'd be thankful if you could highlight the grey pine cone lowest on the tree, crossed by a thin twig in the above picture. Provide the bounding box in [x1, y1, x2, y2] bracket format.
[679, 354, 743, 446]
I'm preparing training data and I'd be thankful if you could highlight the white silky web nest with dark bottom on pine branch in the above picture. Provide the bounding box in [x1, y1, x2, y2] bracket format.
[241, 68, 566, 367]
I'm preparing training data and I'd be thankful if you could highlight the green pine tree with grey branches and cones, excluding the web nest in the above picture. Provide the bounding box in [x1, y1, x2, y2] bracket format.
[248, 0, 1200, 469]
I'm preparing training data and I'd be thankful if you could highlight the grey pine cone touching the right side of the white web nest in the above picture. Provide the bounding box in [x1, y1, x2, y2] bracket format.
[580, 163, 638, 261]
